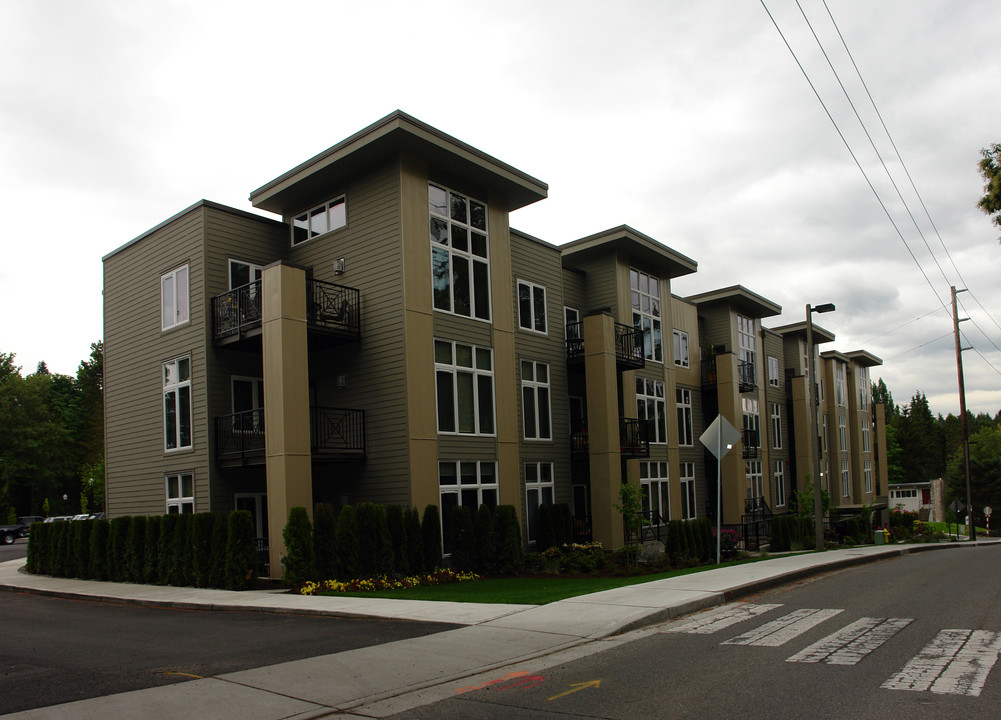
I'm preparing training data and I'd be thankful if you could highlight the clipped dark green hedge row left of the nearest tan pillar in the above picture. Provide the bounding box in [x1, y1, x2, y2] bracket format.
[26, 512, 257, 590]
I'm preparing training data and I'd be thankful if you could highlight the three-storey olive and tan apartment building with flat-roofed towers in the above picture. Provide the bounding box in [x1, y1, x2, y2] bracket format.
[103, 112, 885, 572]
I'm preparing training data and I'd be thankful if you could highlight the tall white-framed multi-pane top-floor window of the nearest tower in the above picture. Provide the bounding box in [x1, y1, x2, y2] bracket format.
[427, 183, 490, 321]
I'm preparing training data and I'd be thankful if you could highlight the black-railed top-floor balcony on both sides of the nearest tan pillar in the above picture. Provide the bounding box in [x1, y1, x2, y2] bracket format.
[212, 278, 361, 344]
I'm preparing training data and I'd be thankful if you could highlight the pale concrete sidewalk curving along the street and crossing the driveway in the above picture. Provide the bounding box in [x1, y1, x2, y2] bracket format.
[0, 541, 1001, 720]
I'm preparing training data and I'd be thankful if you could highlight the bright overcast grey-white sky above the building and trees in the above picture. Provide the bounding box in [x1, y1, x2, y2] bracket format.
[0, 0, 1001, 416]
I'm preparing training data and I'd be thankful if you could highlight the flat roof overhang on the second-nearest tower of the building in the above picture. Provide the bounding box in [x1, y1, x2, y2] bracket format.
[560, 225, 699, 278]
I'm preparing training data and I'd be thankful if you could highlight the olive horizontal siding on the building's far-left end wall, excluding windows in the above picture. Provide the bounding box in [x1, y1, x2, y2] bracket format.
[104, 204, 211, 516]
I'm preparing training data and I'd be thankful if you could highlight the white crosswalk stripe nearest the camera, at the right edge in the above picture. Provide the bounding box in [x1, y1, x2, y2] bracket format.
[881, 630, 1001, 696]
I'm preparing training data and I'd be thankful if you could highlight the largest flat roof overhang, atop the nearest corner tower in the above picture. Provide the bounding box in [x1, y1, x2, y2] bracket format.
[250, 110, 549, 214]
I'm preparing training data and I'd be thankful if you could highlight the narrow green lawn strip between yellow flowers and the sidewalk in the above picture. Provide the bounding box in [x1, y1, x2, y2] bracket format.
[323, 557, 788, 605]
